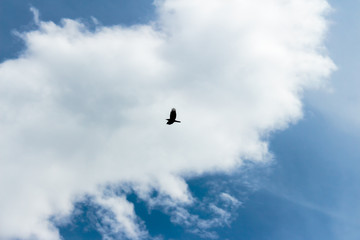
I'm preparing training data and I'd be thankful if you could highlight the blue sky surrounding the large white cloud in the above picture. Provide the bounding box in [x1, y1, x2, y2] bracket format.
[0, 0, 360, 240]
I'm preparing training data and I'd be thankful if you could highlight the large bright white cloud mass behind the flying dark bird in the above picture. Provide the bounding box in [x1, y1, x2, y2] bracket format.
[0, 0, 334, 240]
